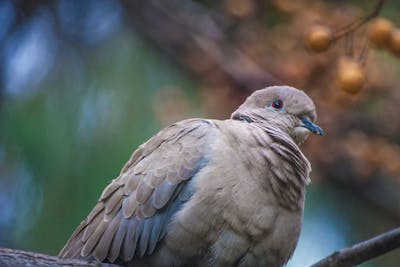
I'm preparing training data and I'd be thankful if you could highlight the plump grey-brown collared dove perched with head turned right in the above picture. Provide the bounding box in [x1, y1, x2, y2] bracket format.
[60, 86, 322, 267]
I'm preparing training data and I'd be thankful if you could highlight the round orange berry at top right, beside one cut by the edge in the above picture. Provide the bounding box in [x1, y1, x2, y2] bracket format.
[368, 18, 393, 48]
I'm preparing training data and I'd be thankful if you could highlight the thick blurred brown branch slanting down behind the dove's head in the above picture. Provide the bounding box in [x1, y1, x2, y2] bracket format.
[123, 0, 282, 90]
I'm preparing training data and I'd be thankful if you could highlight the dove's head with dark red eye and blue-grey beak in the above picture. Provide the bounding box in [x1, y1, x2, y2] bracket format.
[231, 86, 323, 145]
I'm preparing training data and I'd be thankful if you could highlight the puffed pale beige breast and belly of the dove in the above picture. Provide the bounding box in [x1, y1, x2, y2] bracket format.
[169, 122, 304, 266]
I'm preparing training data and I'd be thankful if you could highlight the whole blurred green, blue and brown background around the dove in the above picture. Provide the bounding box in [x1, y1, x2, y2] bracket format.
[0, 0, 400, 267]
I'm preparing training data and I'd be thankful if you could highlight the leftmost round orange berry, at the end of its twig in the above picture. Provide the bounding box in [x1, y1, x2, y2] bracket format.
[305, 25, 333, 52]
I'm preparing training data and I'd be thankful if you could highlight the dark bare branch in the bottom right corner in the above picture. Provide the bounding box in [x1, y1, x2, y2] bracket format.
[311, 227, 400, 267]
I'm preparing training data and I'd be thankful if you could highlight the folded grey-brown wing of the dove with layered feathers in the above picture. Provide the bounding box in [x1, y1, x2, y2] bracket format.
[60, 119, 212, 262]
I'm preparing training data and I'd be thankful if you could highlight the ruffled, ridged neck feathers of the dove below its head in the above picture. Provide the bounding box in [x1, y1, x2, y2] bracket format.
[220, 121, 311, 210]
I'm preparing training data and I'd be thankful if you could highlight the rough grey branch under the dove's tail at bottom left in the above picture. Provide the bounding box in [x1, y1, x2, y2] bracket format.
[0, 248, 119, 267]
